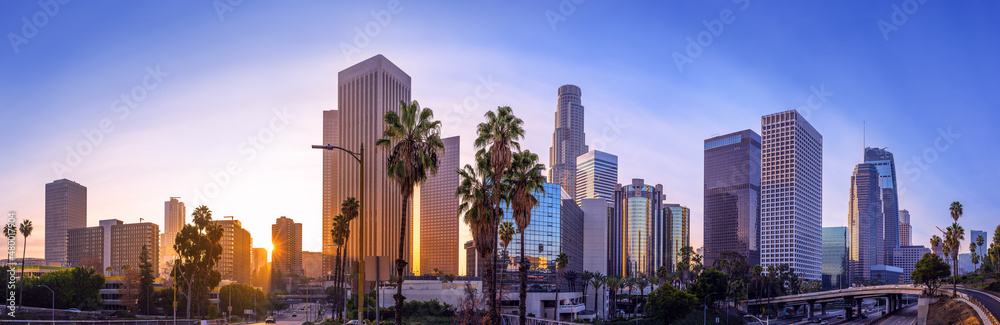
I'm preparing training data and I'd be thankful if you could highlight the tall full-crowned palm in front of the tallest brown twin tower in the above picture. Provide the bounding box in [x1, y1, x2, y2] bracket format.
[375, 101, 444, 325]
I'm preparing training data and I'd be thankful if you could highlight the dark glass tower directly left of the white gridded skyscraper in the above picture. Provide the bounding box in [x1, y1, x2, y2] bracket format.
[703, 130, 760, 265]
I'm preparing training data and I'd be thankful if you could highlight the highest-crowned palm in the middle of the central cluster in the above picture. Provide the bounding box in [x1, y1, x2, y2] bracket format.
[475, 106, 526, 325]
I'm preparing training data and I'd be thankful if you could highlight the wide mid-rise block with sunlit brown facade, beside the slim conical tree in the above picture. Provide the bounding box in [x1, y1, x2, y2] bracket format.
[111, 222, 160, 278]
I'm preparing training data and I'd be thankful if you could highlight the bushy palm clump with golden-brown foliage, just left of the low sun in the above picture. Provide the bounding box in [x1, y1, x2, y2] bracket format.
[171, 205, 224, 319]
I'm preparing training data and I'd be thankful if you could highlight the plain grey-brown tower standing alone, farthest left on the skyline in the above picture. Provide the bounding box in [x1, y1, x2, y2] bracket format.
[45, 178, 87, 264]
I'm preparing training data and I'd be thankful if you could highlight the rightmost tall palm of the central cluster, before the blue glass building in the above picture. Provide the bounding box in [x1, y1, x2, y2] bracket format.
[505, 150, 545, 325]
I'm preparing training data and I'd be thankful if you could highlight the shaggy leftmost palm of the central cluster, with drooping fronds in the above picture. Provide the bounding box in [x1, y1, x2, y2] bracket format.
[455, 152, 497, 318]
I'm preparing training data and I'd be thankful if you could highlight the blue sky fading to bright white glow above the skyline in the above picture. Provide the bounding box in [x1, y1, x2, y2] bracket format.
[0, 0, 1000, 270]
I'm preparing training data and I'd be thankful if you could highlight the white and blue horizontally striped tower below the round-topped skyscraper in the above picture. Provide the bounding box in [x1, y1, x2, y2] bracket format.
[574, 150, 618, 206]
